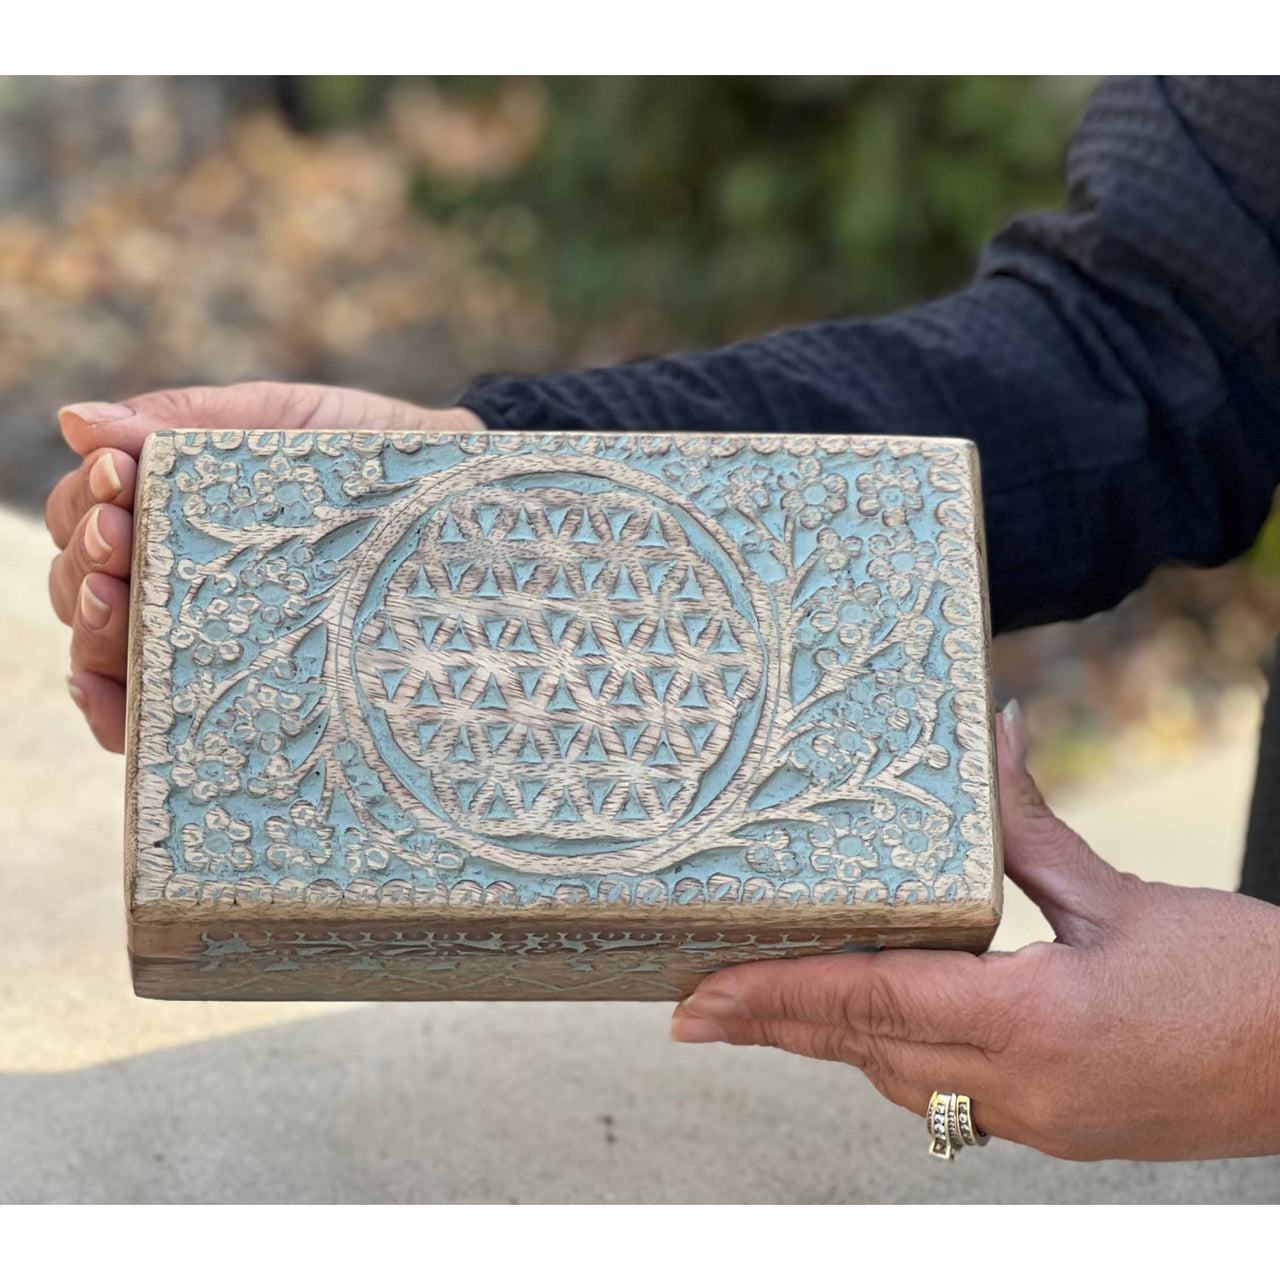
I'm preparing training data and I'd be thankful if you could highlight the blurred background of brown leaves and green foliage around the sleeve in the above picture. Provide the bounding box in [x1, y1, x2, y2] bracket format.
[0, 77, 1280, 788]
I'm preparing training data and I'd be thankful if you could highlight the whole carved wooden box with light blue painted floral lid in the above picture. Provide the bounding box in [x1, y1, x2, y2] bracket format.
[127, 431, 1001, 1000]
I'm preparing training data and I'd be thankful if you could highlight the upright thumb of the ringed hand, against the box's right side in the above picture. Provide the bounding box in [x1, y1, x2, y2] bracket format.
[996, 700, 1124, 946]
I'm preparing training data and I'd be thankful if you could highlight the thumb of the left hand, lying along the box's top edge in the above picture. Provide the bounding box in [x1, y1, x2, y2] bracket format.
[58, 383, 460, 457]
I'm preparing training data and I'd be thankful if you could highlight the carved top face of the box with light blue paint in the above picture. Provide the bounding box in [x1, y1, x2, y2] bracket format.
[152, 434, 988, 905]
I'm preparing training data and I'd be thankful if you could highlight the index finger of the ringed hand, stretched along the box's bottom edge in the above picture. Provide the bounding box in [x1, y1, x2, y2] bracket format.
[680, 951, 1023, 1050]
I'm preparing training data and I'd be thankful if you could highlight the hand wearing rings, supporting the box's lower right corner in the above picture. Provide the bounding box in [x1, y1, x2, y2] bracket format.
[672, 708, 1280, 1160]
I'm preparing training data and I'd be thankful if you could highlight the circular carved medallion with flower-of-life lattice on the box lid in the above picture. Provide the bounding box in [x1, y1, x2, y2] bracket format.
[347, 460, 768, 874]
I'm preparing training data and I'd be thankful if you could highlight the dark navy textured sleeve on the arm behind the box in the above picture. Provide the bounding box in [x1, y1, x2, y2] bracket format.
[462, 77, 1280, 630]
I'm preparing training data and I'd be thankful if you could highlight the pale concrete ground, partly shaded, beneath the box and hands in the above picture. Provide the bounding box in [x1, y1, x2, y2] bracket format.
[0, 511, 1280, 1203]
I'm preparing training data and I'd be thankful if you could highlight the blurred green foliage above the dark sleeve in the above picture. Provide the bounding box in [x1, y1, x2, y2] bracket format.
[289, 76, 1092, 353]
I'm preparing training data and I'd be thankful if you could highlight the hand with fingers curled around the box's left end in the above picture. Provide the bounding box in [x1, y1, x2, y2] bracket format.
[45, 383, 484, 751]
